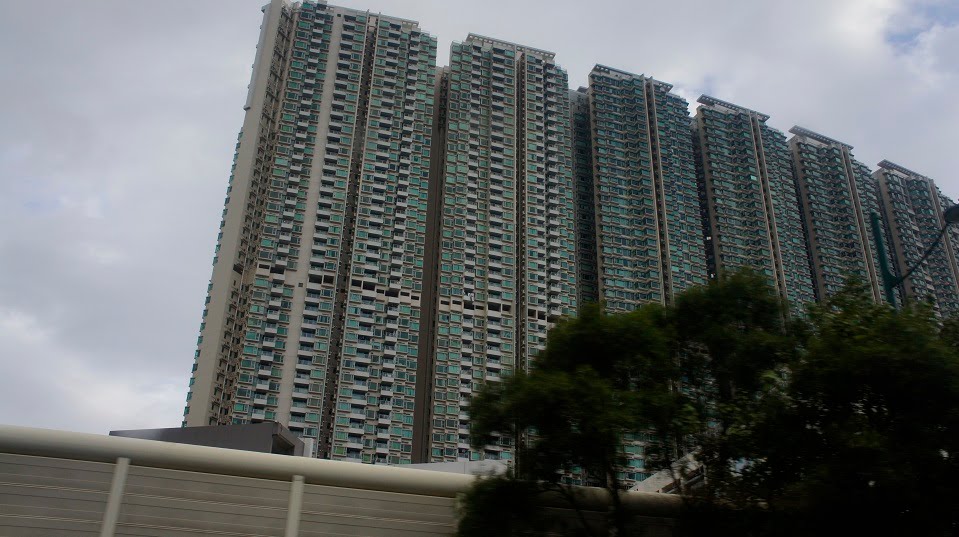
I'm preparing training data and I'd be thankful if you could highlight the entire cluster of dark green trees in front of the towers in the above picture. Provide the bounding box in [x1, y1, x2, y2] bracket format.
[459, 272, 959, 537]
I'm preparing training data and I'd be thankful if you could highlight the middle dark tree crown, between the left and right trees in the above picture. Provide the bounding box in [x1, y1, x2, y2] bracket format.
[670, 270, 801, 501]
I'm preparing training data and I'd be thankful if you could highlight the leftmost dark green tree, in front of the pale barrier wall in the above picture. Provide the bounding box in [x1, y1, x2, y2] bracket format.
[460, 305, 692, 536]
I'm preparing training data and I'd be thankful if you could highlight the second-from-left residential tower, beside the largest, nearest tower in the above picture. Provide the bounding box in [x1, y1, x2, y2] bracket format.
[423, 34, 576, 462]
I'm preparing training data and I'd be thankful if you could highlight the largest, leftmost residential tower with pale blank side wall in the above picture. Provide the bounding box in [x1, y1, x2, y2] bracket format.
[184, 0, 436, 464]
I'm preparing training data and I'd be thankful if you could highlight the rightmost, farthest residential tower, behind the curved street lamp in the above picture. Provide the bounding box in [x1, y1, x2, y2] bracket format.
[873, 160, 959, 315]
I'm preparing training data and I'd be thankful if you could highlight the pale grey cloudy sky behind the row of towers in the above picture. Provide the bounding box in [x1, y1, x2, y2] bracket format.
[0, 0, 959, 433]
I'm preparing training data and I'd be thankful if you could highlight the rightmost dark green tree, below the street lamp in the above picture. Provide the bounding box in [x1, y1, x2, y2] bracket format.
[687, 282, 959, 536]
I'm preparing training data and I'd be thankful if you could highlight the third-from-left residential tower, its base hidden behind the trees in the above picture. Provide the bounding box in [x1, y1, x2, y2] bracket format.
[577, 65, 707, 312]
